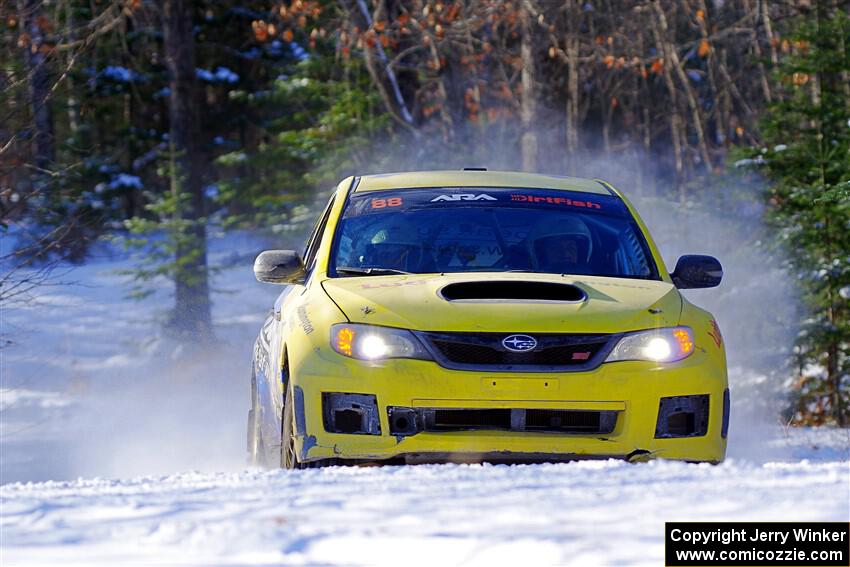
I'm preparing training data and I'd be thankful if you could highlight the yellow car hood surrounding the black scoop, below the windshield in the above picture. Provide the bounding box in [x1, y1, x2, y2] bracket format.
[322, 273, 682, 333]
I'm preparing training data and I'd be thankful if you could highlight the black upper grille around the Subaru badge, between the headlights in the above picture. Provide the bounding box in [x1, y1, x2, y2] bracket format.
[420, 333, 613, 372]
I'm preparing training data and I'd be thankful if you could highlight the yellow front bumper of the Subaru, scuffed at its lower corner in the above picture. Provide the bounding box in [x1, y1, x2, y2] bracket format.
[290, 349, 728, 462]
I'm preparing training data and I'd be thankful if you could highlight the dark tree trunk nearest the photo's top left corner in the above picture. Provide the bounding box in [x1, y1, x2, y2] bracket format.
[18, 0, 55, 170]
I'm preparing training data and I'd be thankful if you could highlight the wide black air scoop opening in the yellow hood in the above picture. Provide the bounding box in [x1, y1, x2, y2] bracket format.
[437, 280, 587, 303]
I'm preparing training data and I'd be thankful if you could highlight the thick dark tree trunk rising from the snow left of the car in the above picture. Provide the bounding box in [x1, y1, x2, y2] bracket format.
[162, 0, 212, 340]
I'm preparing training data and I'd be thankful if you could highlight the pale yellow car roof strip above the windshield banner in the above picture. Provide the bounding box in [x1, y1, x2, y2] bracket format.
[355, 170, 614, 195]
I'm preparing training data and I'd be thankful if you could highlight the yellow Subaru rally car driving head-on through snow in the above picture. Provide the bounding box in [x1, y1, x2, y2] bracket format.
[248, 170, 729, 468]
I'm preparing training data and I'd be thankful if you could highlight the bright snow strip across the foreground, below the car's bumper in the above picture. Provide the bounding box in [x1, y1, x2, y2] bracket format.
[0, 448, 850, 566]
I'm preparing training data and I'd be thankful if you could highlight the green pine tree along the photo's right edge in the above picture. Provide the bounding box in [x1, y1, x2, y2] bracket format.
[753, 6, 850, 426]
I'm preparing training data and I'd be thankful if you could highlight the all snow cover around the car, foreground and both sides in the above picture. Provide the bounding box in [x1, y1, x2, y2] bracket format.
[0, 229, 850, 567]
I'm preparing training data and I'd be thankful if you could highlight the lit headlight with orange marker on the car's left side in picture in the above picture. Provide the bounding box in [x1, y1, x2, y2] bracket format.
[331, 323, 431, 360]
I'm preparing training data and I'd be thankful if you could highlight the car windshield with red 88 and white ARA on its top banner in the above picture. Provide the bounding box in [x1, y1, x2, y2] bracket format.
[330, 187, 658, 279]
